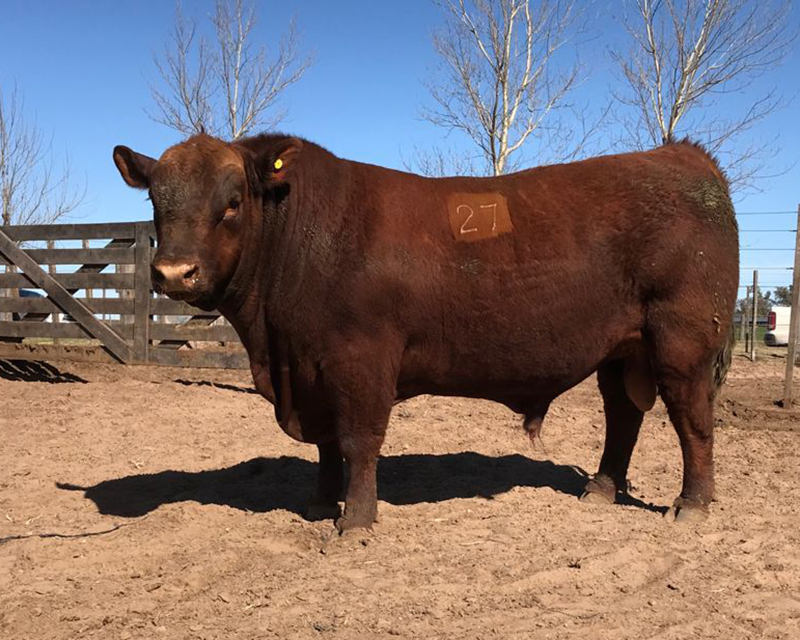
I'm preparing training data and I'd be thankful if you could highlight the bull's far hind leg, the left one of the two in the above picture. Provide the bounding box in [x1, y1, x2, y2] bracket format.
[581, 360, 644, 504]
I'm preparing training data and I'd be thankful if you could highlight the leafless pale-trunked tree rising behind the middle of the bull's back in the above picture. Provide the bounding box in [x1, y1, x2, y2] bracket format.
[417, 0, 595, 175]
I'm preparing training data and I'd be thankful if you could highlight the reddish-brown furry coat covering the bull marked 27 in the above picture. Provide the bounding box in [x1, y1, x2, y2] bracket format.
[115, 135, 738, 529]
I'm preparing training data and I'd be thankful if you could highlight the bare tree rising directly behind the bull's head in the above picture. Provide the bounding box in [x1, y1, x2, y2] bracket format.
[148, 0, 311, 140]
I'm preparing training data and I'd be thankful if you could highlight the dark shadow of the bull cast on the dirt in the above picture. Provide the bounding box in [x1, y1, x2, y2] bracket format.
[58, 452, 659, 517]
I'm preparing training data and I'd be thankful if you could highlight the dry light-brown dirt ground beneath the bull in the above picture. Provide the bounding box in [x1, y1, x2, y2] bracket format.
[0, 356, 800, 640]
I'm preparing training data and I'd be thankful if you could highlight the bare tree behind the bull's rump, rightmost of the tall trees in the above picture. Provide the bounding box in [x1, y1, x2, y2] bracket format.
[612, 0, 796, 187]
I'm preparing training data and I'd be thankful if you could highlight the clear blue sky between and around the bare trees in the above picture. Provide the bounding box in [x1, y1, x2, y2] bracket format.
[0, 0, 800, 294]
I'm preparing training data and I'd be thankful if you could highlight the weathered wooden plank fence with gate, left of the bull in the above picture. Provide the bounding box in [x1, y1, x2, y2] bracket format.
[0, 222, 247, 368]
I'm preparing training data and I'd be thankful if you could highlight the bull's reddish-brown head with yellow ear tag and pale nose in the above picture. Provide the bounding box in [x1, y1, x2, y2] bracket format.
[114, 134, 302, 309]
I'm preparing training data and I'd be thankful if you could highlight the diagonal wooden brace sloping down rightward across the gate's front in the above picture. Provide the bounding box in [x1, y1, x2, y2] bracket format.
[0, 231, 132, 362]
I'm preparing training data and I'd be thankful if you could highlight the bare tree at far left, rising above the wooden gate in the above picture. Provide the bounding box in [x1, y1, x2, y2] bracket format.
[0, 86, 86, 225]
